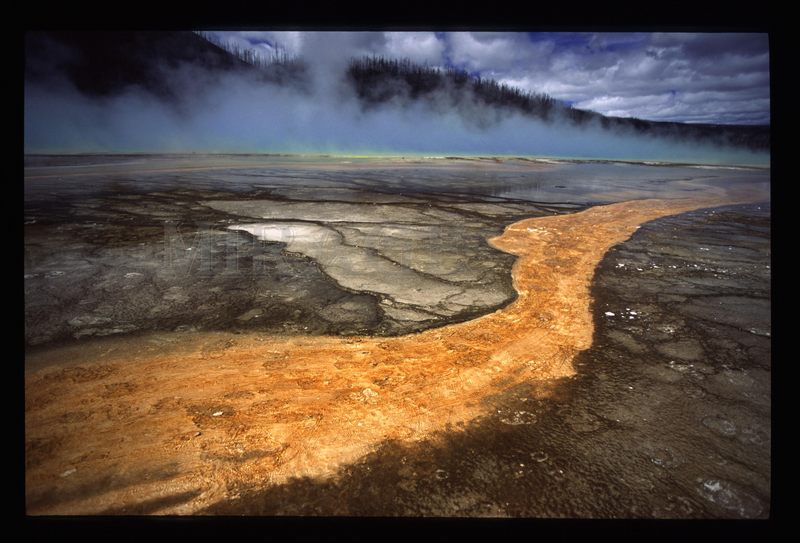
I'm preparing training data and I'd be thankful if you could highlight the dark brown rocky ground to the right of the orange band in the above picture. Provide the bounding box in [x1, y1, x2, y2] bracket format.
[206, 205, 771, 518]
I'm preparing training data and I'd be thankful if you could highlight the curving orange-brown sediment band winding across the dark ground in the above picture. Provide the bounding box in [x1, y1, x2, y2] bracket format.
[25, 196, 727, 514]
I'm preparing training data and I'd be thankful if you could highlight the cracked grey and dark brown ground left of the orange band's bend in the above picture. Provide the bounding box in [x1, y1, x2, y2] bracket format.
[25, 162, 579, 346]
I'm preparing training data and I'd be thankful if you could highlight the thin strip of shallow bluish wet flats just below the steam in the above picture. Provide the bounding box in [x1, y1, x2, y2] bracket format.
[25, 157, 770, 209]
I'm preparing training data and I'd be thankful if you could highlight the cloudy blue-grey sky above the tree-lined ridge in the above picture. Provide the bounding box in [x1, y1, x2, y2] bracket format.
[205, 31, 770, 124]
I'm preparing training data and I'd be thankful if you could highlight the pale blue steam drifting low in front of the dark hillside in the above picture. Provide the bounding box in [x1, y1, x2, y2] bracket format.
[24, 50, 769, 165]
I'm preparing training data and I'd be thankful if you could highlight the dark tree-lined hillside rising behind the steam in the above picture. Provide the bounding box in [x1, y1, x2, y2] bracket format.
[25, 32, 770, 151]
